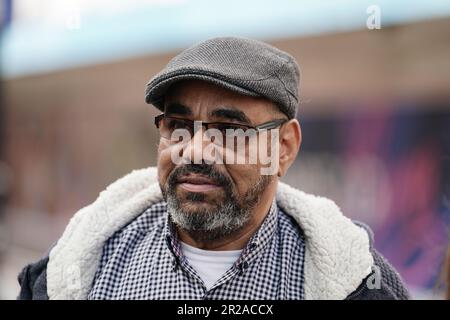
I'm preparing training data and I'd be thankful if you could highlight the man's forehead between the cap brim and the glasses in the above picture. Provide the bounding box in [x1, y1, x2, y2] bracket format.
[164, 80, 277, 119]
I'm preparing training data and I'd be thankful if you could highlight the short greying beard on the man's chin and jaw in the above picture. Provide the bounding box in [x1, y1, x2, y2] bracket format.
[165, 170, 271, 242]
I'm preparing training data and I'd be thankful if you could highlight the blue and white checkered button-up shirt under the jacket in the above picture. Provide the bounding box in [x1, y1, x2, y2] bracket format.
[88, 202, 305, 300]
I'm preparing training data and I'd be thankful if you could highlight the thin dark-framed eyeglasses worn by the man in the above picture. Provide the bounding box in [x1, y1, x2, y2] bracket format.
[155, 113, 288, 139]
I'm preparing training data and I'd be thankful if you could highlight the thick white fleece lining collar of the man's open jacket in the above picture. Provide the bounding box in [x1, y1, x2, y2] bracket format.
[47, 167, 373, 299]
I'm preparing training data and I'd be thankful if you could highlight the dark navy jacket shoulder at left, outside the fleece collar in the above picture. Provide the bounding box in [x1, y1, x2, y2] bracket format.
[17, 256, 49, 300]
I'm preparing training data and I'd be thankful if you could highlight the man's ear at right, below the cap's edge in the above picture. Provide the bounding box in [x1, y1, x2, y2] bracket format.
[278, 119, 302, 177]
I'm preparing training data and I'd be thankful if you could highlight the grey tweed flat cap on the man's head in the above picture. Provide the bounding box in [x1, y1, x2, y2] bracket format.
[145, 37, 300, 119]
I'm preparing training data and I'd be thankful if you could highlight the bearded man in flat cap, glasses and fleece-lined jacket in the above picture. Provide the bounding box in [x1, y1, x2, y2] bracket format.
[19, 37, 408, 299]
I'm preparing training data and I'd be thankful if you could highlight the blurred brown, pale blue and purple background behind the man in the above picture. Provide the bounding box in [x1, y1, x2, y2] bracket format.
[0, 0, 450, 299]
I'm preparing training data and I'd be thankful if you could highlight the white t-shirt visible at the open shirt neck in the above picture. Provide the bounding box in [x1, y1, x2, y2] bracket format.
[181, 242, 242, 290]
